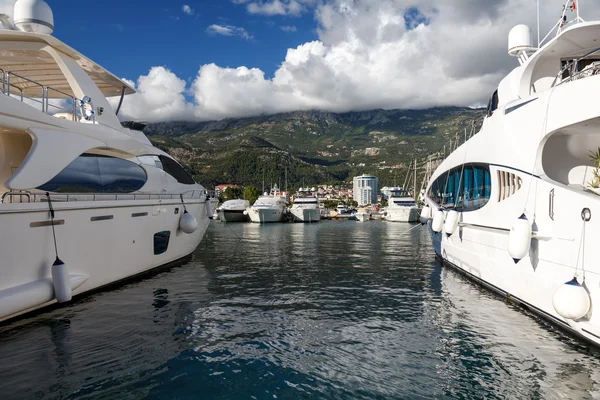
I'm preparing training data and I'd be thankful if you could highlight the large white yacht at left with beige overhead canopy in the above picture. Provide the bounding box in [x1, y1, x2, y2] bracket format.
[0, 0, 214, 320]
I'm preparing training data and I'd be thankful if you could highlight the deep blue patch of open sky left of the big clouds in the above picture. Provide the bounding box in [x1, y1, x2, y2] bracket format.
[48, 0, 317, 80]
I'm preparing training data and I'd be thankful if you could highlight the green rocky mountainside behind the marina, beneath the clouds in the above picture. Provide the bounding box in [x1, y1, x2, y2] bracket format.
[146, 107, 483, 189]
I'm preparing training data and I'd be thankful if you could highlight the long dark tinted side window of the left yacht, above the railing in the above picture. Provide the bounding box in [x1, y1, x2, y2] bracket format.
[38, 154, 147, 193]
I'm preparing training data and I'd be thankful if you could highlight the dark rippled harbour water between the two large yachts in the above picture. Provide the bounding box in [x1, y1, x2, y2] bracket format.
[0, 221, 600, 400]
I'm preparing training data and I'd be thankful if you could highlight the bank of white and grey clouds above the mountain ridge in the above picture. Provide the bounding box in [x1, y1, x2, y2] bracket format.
[113, 0, 600, 120]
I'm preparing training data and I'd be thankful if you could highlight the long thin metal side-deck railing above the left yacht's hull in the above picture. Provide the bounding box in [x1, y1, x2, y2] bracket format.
[1, 189, 211, 204]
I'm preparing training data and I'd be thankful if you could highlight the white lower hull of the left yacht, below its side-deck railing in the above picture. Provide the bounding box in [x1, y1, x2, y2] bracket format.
[0, 200, 213, 321]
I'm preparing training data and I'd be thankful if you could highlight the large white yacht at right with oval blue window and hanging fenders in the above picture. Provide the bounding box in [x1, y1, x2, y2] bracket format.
[421, 1, 600, 345]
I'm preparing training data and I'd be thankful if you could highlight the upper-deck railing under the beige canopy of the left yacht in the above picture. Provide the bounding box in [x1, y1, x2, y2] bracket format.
[0, 67, 95, 123]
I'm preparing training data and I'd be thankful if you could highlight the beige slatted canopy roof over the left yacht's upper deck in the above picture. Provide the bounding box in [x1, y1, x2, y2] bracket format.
[0, 30, 135, 97]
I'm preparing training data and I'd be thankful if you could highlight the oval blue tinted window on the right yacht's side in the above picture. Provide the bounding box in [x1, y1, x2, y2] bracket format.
[429, 164, 492, 211]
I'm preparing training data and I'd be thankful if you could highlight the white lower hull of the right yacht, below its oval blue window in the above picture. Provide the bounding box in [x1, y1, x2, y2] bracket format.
[428, 171, 600, 345]
